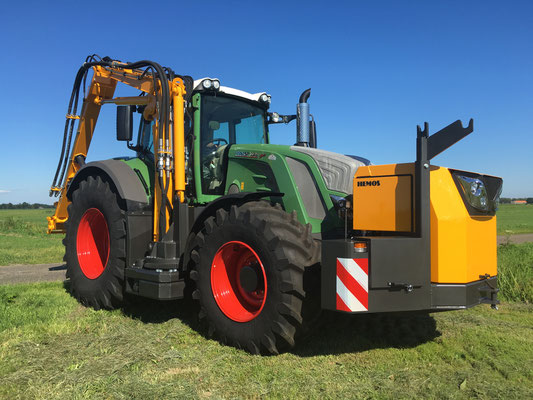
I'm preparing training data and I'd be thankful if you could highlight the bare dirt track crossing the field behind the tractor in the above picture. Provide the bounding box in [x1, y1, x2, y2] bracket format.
[0, 233, 533, 285]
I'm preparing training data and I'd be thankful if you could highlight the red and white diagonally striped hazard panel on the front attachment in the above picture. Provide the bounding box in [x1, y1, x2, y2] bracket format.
[337, 258, 368, 312]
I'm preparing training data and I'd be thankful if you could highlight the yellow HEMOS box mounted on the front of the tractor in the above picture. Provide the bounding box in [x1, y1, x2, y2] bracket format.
[353, 163, 497, 283]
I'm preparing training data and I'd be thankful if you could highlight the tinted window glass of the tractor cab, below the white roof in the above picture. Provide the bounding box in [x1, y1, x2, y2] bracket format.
[200, 95, 267, 194]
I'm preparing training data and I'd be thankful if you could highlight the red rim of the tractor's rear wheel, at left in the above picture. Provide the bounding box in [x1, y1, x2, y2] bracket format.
[76, 208, 109, 279]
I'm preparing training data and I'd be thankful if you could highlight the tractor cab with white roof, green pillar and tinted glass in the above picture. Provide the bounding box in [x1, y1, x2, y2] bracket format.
[189, 78, 270, 201]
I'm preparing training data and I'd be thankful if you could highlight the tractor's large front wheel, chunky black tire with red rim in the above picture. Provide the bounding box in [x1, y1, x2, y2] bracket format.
[190, 201, 320, 354]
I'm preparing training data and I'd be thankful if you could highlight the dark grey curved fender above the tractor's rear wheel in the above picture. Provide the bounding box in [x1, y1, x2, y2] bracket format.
[67, 159, 149, 211]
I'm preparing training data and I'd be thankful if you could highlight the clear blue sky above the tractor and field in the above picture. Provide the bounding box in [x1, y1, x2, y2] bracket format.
[0, 1, 533, 203]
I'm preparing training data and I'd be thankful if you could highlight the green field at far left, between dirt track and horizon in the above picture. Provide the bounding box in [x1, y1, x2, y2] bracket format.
[0, 210, 64, 265]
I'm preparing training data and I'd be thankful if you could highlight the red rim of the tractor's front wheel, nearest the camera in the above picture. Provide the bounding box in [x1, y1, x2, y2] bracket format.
[211, 241, 267, 322]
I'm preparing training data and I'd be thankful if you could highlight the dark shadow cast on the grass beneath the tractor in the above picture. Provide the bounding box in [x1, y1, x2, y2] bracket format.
[63, 280, 440, 357]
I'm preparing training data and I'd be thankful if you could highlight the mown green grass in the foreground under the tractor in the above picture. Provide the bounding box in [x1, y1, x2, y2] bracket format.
[0, 283, 533, 399]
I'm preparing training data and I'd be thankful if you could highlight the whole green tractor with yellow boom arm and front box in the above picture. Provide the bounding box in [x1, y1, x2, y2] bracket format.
[49, 57, 501, 354]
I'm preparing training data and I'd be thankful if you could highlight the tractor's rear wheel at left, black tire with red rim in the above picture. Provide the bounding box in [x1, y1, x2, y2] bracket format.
[63, 176, 126, 310]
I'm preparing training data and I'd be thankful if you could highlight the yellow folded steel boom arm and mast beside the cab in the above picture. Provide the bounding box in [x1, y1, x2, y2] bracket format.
[47, 66, 185, 240]
